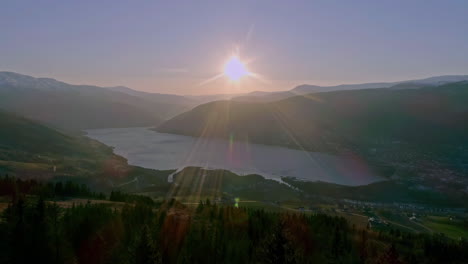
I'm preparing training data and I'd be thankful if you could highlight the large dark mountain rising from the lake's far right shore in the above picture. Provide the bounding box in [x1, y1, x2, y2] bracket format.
[156, 82, 468, 193]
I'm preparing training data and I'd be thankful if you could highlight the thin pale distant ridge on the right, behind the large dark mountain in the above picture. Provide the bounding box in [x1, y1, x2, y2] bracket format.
[232, 75, 468, 102]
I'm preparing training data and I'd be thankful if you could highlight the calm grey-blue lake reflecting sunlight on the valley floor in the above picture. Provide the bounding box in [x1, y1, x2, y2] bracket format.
[87, 128, 382, 185]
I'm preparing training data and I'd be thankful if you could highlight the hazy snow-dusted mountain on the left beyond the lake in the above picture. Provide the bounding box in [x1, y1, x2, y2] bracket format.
[0, 72, 194, 130]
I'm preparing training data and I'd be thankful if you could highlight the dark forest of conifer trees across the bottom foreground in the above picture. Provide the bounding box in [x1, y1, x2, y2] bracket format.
[0, 185, 468, 264]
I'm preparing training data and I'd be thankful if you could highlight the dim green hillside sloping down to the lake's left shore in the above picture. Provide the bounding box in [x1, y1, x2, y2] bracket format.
[0, 111, 170, 188]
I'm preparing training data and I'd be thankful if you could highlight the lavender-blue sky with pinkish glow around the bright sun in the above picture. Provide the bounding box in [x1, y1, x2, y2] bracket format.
[0, 0, 468, 94]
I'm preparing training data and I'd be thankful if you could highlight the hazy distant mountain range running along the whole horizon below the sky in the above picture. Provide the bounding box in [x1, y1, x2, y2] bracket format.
[0, 72, 468, 134]
